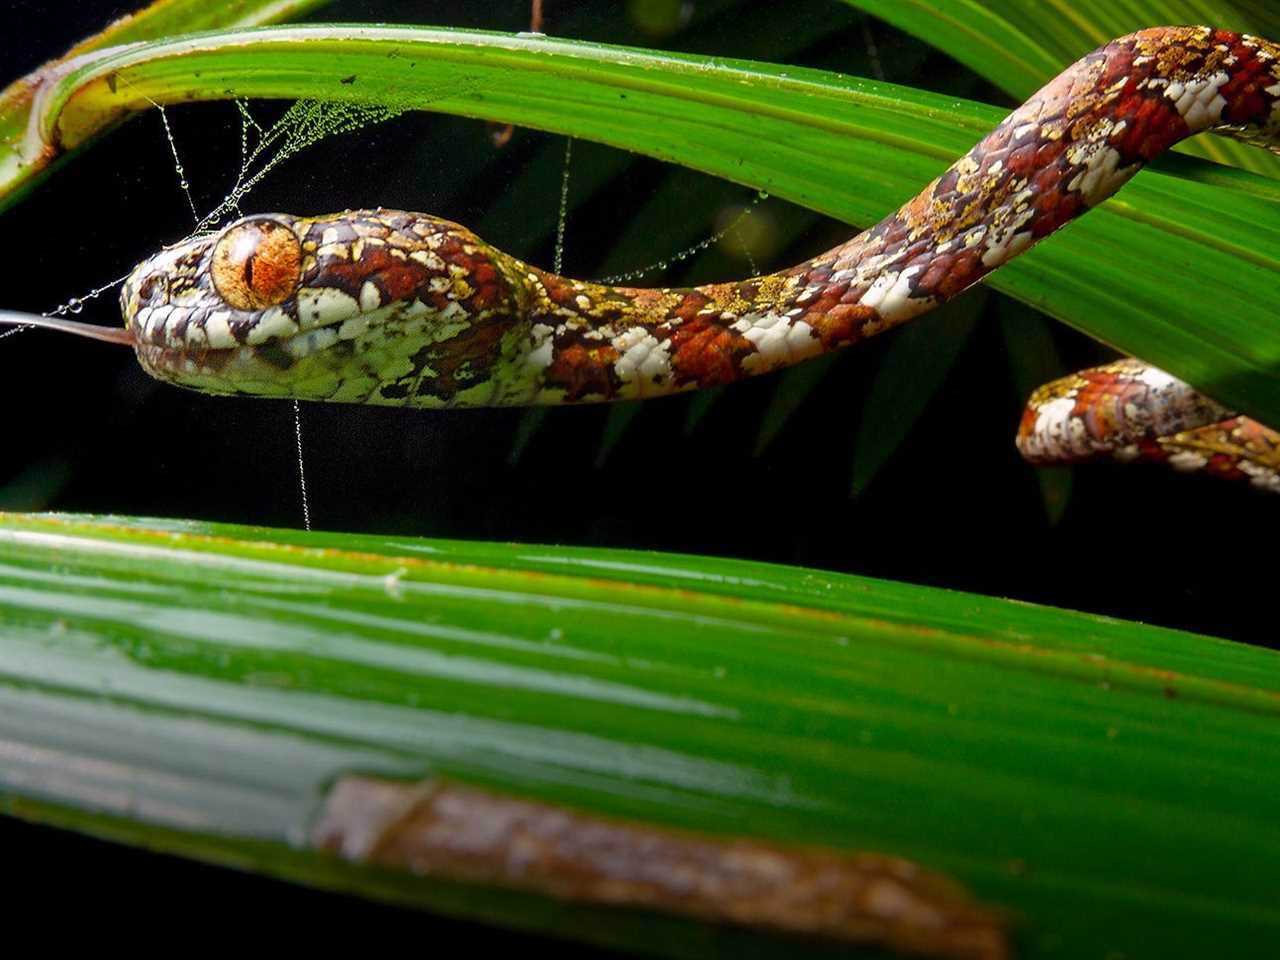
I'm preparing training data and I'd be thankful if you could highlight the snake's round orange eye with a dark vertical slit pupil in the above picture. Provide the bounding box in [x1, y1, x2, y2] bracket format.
[211, 216, 302, 310]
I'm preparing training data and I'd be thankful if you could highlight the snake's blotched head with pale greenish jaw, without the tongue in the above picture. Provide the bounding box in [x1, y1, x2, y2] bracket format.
[120, 210, 527, 407]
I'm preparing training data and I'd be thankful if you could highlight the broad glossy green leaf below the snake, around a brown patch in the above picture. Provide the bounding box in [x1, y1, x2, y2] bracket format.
[0, 515, 1280, 957]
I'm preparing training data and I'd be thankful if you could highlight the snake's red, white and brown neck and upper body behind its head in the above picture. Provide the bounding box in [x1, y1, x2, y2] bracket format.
[518, 27, 1280, 403]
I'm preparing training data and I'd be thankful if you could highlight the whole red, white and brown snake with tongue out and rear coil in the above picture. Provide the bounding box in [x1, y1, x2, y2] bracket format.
[7, 27, 1280, 492]
